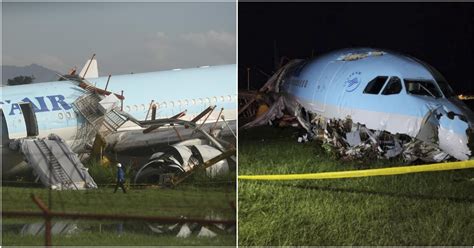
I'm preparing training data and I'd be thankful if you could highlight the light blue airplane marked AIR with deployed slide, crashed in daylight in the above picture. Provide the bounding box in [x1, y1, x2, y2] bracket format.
[0, 55, 237, 189]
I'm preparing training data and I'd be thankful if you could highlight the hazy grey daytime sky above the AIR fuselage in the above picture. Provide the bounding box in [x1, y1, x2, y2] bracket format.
[2, 2, 236, 75]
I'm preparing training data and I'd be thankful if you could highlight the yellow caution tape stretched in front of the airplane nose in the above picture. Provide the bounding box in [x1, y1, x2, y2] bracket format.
[238, 160, 474, 180]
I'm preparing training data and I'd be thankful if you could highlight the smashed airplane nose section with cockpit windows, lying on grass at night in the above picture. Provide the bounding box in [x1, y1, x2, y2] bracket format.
[239, 48, 474, 162]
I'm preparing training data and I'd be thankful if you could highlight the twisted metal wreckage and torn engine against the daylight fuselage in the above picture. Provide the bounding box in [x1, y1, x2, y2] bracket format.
[74, 89, 236, 186]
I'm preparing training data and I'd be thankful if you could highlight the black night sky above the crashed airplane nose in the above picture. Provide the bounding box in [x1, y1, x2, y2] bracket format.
[238, 3, 474, 94]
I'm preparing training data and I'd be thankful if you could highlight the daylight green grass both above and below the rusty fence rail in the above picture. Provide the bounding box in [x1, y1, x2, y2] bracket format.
[2, 182, 236, 246]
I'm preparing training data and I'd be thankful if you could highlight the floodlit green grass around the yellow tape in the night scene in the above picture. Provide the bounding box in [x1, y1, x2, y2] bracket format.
[238, 127, 474, 245]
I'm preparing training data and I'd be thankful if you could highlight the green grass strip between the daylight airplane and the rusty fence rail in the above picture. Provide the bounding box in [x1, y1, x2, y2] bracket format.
[2, 186, 235, 218]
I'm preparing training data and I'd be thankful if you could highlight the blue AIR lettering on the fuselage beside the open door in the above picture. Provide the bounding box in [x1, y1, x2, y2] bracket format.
[0, 95, 72, 115]
